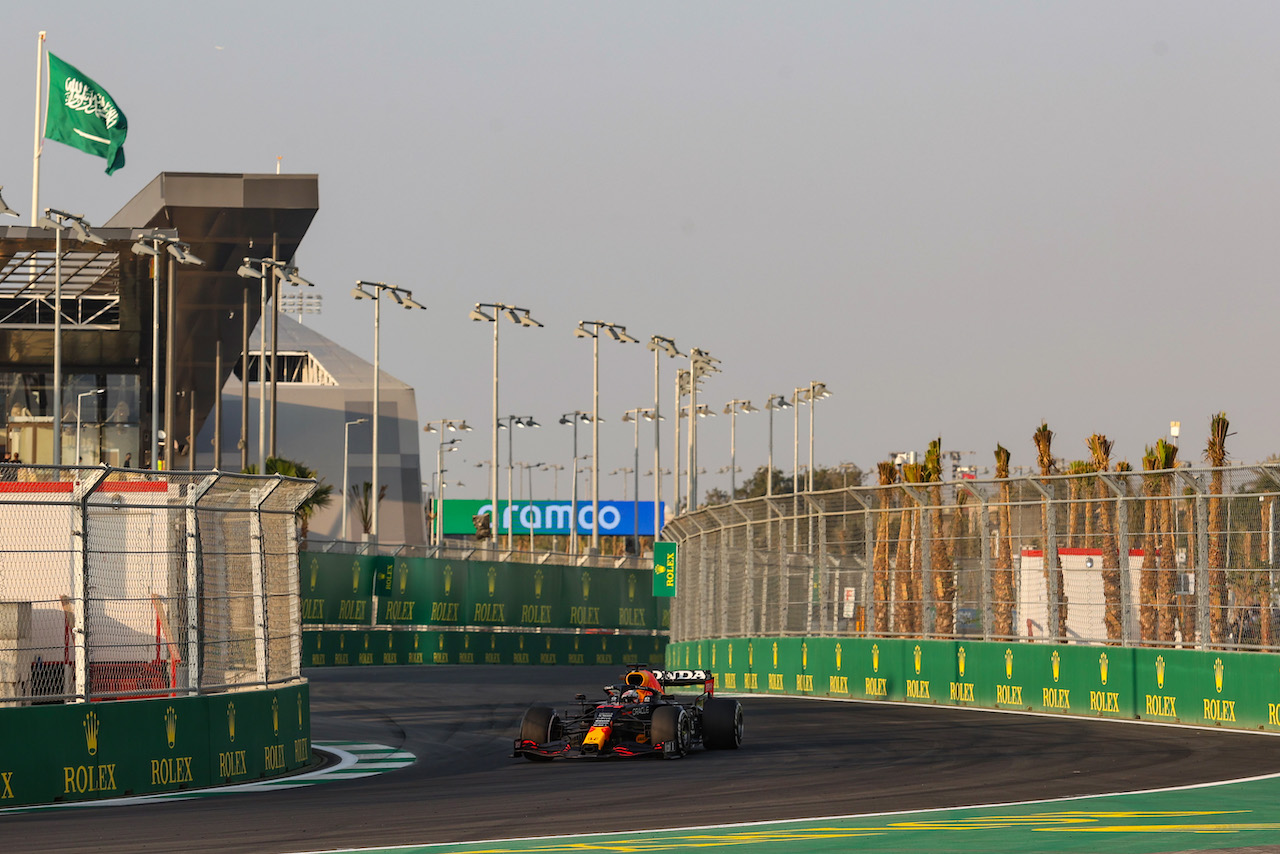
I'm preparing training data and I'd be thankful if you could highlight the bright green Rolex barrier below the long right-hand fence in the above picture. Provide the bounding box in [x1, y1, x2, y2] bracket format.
[666, 638, 1280, 731]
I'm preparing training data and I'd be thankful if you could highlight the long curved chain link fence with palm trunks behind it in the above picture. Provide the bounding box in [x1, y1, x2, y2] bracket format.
[664, 465, 1280, 650]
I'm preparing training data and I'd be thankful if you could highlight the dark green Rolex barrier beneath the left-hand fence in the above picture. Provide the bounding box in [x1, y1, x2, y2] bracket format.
[0, 684, 311, 808]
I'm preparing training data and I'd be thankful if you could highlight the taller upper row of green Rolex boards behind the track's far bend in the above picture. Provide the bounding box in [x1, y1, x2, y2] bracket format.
[301, 552, 671, 631]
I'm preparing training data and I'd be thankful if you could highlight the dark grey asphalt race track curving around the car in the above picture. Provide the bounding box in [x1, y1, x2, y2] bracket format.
[0, 666, 1280, 854]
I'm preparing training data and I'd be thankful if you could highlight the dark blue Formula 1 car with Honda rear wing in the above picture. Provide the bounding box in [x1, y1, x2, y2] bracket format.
[512, 668, 742, 762]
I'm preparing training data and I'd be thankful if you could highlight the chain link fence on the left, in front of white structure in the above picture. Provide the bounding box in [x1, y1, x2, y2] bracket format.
[0, 463, 315, 707]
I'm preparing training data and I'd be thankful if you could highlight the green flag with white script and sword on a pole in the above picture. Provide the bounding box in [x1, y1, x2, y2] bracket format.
[45, 54, 129, 174]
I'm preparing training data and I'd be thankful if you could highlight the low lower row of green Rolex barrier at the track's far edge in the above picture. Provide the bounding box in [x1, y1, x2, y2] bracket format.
[302, 629, 667, 667]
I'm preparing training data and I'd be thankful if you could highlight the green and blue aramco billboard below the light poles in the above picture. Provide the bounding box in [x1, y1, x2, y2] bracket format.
[444, 498, 666, 536]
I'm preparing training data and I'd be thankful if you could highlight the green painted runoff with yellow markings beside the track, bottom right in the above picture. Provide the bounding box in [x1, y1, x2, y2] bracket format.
[317, 695, 1280, 854]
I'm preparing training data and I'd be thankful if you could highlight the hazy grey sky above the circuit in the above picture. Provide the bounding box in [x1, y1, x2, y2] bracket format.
[0, 0, 1280, 498]
